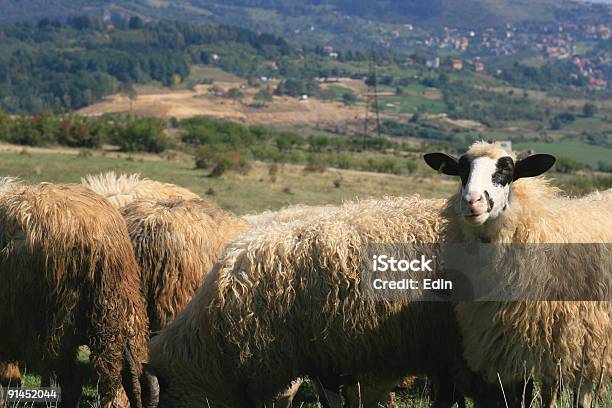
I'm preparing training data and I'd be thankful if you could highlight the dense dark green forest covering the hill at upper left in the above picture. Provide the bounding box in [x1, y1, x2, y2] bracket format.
[0, 16, 290, 113]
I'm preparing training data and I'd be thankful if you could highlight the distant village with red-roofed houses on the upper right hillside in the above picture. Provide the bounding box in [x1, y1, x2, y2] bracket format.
[313, 4, 612, 91]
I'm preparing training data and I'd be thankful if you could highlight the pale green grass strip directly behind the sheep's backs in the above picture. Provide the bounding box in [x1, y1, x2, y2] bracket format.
[0, 147, 454, 214]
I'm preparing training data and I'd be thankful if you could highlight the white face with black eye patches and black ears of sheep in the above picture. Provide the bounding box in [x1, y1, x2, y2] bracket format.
[425, 153, 555, 224]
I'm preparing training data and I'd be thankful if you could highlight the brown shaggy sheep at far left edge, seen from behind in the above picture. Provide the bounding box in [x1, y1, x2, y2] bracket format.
[0, 183, 148, 407]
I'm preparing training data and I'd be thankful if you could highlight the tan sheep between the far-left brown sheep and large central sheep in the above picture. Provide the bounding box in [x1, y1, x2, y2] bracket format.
[120, 198, 246, 332]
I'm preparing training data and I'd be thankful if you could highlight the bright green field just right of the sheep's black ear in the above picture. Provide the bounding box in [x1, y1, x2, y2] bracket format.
[514, 141, 612, 167]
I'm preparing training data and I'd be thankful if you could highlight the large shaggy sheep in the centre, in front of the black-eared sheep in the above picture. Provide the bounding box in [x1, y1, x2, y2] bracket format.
[143, 196, 502, 407]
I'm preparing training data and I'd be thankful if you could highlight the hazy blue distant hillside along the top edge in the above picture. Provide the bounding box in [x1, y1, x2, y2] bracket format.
[0, 0, 565, 37]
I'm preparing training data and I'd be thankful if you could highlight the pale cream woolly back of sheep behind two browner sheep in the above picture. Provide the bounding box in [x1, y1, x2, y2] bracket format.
[81, 171, 199, 208]
